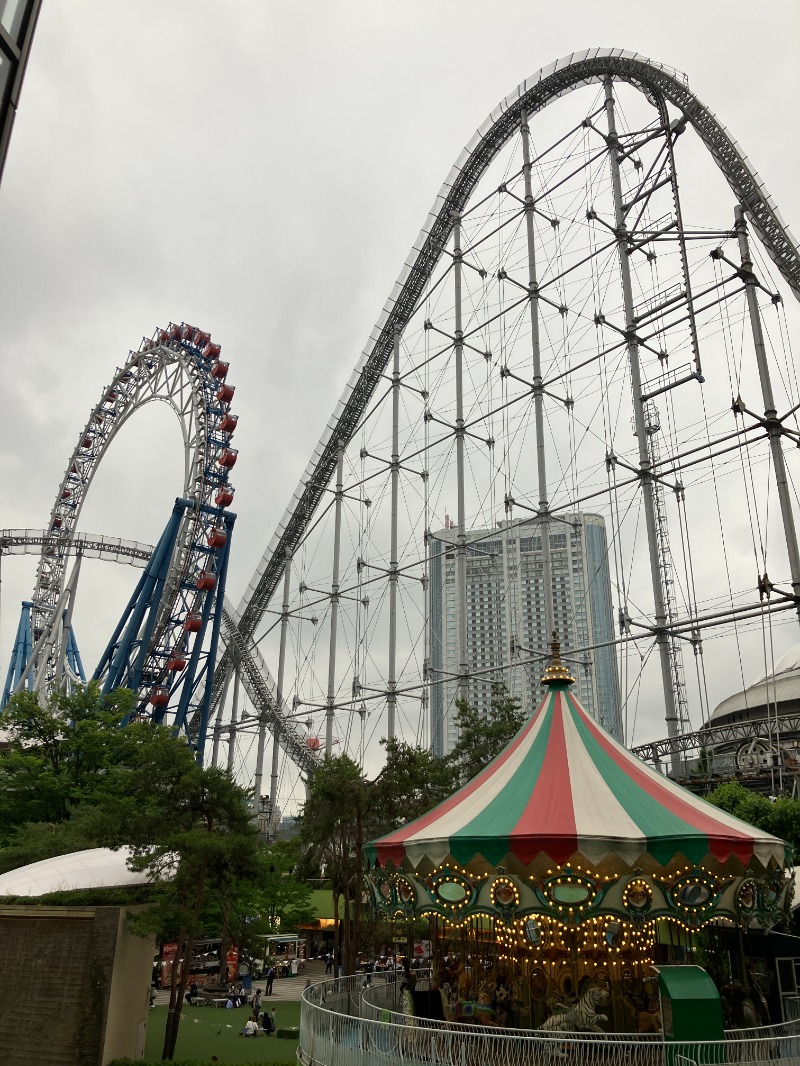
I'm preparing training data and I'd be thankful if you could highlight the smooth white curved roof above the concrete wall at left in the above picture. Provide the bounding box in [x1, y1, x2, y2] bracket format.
[0, 847, 153, 897]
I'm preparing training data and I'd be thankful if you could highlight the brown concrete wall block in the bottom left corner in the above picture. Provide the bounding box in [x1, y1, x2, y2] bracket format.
[0, 907, 154, 1066]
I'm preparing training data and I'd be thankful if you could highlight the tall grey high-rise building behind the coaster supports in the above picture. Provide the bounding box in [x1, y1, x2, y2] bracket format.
[429, 512, 622, 755]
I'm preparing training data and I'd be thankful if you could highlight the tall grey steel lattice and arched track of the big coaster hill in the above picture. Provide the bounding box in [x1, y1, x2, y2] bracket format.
[215, 49, 800, 793]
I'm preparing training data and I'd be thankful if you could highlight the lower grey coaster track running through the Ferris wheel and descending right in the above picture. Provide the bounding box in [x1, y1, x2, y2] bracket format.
[0, 530, 319, 773]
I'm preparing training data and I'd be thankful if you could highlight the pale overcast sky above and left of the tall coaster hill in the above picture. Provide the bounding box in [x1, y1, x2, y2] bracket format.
[0, 0, 800, 801]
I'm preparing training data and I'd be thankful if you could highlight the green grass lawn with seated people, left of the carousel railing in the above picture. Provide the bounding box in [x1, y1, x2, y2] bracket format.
[144, 1000, 300, 1063]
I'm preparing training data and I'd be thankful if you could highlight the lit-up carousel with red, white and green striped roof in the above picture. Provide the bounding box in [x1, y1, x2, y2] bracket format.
[367, 641, 793, 1033]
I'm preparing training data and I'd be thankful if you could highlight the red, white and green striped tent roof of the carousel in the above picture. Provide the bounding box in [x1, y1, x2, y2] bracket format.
[367, 647, 786, 874]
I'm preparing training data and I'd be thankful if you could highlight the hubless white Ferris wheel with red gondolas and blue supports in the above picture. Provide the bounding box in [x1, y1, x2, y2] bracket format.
[6, 323, 238, 741]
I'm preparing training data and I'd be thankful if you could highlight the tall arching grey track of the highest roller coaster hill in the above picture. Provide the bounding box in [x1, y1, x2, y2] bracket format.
[214, 49, 800, 733]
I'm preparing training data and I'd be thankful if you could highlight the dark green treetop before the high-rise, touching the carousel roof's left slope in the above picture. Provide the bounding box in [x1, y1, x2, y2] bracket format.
[450, 684, 526, 781]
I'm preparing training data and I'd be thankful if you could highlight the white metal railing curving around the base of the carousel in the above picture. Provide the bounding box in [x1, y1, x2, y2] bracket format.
[298, 974, 800, 1066]
